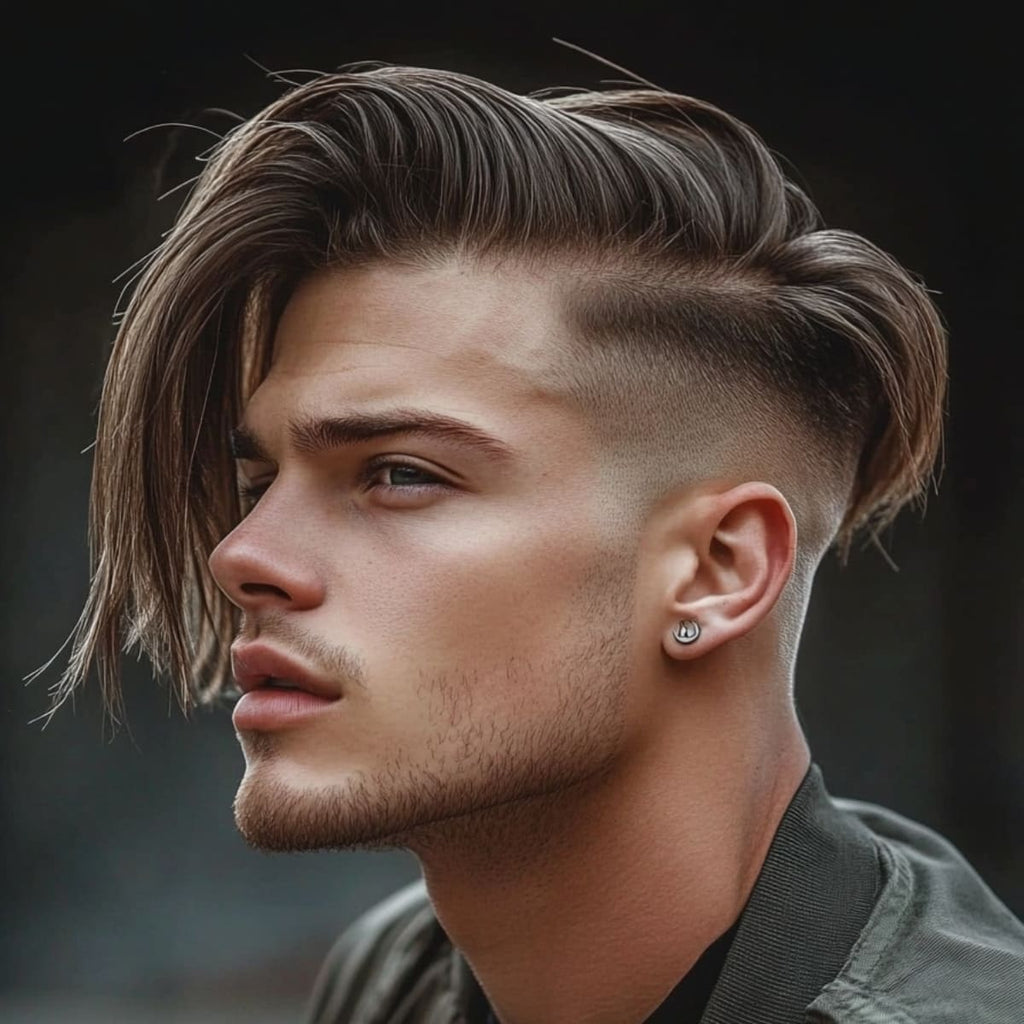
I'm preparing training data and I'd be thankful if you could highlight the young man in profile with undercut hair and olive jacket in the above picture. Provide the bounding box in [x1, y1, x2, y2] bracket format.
[60, 67, 1024, 1024]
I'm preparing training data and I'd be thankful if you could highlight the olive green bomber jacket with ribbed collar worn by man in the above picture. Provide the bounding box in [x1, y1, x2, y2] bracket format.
[308, 765, 1024, 1024]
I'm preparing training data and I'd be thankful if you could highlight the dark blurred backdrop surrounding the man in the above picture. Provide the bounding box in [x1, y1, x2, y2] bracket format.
[0, 0, 1024, 1022]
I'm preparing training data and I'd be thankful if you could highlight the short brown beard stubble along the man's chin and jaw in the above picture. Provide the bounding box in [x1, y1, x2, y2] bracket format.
[234, 561, 632, 854]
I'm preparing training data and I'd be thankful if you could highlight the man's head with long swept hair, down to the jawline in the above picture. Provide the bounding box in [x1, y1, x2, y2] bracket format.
[65, 61, 944, 847]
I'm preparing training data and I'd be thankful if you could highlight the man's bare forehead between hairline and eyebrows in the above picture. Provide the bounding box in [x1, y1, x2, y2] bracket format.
[240, 265, 584, 449]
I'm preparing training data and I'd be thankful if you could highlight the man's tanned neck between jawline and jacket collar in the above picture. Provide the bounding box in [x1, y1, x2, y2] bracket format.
[405, 675, 810, 1024]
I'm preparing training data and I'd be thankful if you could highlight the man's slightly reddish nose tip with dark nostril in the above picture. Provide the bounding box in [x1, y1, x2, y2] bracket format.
[208, 510, 325, 614]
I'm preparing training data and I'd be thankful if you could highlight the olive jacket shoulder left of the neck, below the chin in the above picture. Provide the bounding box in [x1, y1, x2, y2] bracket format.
[306, 880, 451, 1024]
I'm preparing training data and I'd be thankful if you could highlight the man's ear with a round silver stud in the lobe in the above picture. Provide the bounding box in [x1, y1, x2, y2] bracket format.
[663, 482, 797, 660]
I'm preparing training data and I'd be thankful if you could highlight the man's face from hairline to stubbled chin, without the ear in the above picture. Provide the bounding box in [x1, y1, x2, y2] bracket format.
[210, 263, 634, 849]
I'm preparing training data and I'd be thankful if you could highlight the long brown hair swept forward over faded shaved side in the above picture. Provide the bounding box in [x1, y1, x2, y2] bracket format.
[46, 65, 945, 719]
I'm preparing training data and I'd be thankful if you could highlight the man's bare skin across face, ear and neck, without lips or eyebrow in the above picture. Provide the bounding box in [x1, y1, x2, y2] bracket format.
[210, 262, 809, 1024]
